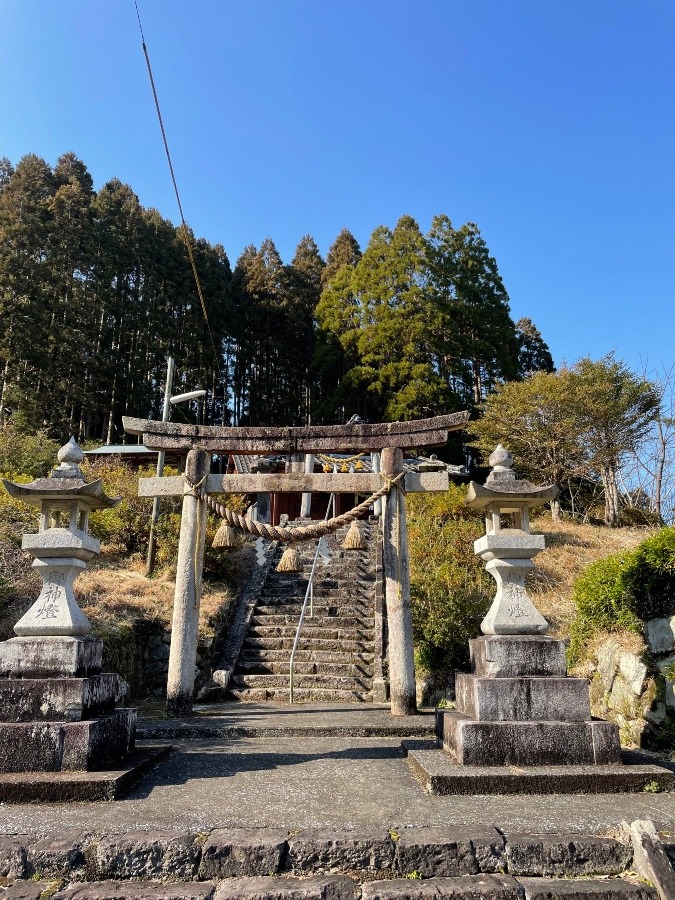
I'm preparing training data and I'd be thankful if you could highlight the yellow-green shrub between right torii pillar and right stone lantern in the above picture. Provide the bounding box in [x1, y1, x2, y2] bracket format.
[407, 485, 495, 673]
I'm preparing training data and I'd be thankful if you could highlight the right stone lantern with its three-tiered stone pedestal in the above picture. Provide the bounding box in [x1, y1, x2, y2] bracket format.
[436, 445, 620, 767]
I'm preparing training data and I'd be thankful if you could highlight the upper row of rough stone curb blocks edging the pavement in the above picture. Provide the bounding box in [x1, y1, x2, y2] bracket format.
[0, 826, 633, 884]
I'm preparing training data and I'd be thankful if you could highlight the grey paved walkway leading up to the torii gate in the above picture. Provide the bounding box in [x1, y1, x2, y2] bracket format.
[0, 704, 675, 834]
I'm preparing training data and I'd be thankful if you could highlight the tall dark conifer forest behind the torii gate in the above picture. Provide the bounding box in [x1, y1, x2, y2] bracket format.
[0, 153, 553, 443]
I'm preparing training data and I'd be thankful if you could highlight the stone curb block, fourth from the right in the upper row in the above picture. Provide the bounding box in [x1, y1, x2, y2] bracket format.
[199, 828, 286, 879]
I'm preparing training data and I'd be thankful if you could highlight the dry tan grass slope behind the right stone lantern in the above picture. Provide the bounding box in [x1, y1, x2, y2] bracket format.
[527, 516, 650, 638]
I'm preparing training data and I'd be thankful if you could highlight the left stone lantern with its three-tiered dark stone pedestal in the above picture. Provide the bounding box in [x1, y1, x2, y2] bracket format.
[0, 438, 136, 776]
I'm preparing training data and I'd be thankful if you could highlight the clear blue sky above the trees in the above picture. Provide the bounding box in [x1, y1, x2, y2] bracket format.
[0, 0, 675, 369]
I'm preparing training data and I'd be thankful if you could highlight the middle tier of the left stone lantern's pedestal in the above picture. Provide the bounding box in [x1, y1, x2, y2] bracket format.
[0, 674, 121, 722]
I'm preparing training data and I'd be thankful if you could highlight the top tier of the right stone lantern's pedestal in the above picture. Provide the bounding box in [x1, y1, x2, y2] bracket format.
[469, 635, 567, 678]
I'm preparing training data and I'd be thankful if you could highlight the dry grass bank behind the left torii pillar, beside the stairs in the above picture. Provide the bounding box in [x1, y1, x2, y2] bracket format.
[75, 549, 252, 637]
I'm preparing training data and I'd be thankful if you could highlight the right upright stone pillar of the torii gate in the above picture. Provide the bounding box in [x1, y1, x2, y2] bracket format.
[382, 447, 417, 716]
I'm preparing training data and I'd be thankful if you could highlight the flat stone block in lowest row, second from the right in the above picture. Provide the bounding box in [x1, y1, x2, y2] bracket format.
[362, 875, 523, 900]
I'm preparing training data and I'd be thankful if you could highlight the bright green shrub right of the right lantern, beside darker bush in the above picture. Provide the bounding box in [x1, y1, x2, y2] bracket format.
[569, 551, 642, 664]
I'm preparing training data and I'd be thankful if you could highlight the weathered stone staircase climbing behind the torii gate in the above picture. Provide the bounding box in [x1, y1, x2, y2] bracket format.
[228, 522, 381, 703]
